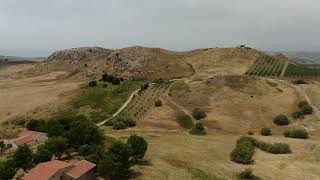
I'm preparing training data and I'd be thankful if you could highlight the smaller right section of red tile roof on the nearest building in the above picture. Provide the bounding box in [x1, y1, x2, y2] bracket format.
[66, 160, 96, 178]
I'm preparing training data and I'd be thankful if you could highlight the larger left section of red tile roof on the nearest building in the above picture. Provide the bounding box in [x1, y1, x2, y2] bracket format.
[22, 160, 73, 180]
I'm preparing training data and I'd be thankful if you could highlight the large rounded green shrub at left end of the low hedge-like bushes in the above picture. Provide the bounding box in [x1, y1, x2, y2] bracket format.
[230, 136, 254, 164]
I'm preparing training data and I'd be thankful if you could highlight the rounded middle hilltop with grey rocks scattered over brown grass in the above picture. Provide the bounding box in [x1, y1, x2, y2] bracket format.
[107, 47, 192, 79]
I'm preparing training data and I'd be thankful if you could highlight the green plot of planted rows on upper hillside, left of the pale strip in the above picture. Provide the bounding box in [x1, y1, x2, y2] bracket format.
[246, 55, 285, 77]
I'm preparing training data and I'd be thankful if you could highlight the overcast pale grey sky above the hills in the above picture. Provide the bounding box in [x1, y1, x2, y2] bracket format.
[0, 0, 320, 56]
